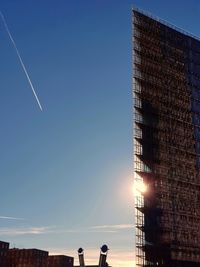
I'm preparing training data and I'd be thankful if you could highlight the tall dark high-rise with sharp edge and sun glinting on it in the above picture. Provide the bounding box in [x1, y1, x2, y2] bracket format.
[133, 9, 200, 267]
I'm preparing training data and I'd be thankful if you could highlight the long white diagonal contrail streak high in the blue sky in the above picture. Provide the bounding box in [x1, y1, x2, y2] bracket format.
[0, 11, 42, 111]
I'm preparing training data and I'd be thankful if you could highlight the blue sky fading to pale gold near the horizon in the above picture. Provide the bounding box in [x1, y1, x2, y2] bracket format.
[0, 0, 200, 267]
